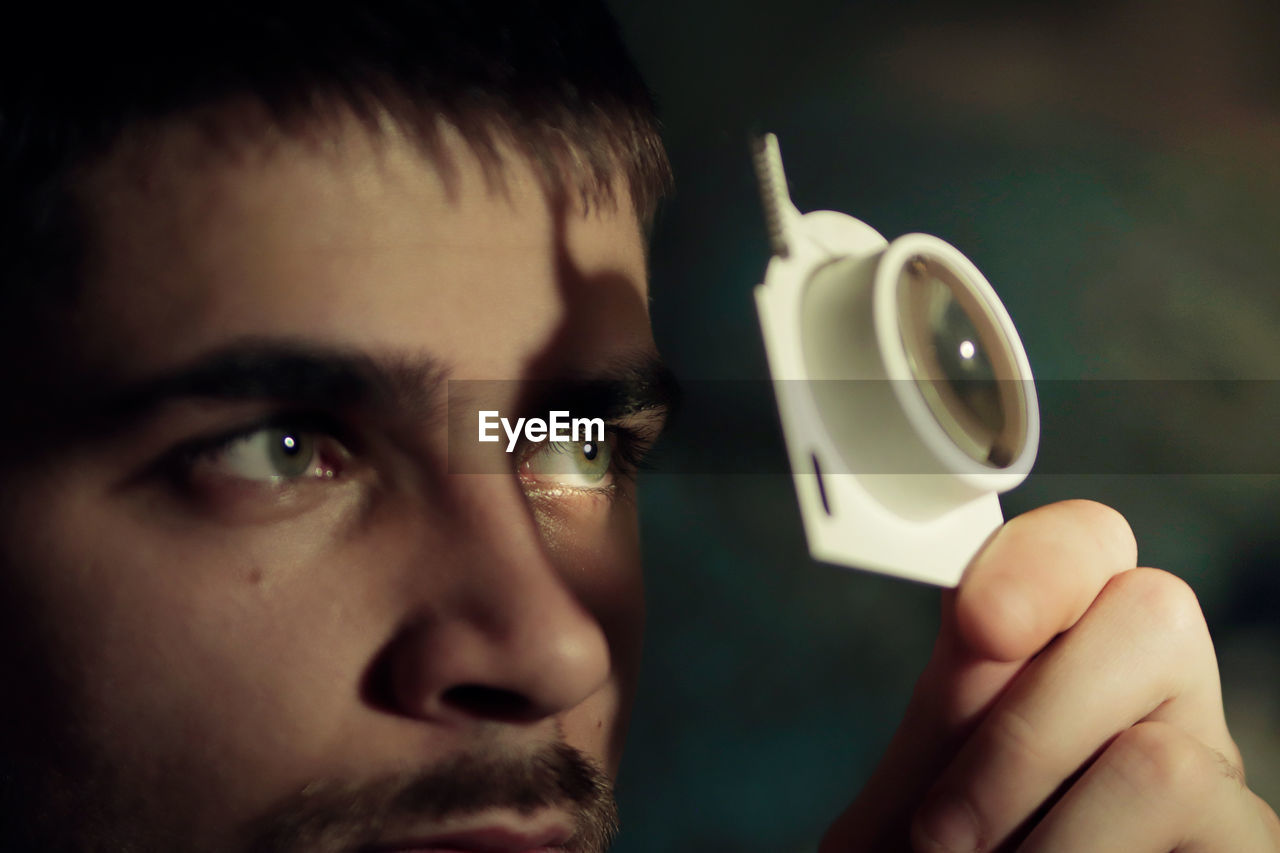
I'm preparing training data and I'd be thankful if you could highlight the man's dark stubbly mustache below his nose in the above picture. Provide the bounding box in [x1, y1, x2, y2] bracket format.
[246, 743, 618, 853]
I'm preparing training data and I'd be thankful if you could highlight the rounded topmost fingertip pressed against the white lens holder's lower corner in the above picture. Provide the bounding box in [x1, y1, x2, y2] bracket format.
[955, 501, 1138, 661]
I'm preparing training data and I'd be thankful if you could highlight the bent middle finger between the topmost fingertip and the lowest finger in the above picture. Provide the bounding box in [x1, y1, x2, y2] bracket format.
[913, 569, 1239, 850]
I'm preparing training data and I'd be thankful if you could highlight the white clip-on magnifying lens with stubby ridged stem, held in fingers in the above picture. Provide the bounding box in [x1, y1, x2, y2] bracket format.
[755, 133, 1039, 587]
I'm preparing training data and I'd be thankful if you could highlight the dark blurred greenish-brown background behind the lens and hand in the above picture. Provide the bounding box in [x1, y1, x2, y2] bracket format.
[612, 0, 1280, 853]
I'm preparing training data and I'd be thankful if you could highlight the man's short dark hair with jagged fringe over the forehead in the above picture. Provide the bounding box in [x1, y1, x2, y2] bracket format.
[0, 0, 669, 314]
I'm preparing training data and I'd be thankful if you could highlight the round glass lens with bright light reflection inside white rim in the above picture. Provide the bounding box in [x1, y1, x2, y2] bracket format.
[897, 255, 1027, 467]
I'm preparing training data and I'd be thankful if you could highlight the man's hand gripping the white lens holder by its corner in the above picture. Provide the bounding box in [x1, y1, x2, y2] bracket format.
[822, 501, 1280, 853]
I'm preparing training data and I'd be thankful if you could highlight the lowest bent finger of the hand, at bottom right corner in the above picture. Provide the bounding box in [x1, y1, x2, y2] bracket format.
[1019, 722, 1280, 853]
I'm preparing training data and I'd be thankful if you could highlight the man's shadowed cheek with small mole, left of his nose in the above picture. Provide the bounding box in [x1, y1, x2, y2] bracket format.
[0, 471, 381, 831]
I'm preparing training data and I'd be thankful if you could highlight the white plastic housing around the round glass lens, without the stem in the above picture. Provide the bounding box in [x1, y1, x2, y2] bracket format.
[755, 204, 1039, 587]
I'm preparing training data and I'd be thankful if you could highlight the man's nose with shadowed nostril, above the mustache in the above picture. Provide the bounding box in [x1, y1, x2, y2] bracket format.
[381, 475, 611, 724]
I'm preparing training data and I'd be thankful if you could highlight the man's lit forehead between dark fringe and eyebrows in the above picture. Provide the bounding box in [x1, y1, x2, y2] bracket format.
[63, 112, 652, 379]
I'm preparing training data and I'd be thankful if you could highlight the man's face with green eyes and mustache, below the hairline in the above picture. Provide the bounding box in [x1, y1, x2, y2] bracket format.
[0, 114, 657, 850]
